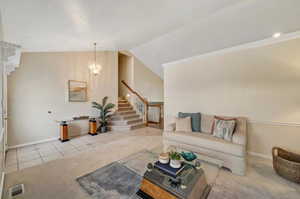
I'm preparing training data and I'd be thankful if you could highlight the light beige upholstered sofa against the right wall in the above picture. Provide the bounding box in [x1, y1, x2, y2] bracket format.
[163, 114, 247, 175]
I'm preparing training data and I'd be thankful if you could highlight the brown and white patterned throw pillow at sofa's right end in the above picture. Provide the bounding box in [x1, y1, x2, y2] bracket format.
[212, 116, 236, 142]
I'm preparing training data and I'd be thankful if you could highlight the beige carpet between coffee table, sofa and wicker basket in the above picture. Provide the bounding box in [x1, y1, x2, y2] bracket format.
[208, 161, 300, 199]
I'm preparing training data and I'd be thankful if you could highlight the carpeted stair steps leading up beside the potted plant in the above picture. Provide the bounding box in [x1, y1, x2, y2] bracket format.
[108, 99, 146, 131]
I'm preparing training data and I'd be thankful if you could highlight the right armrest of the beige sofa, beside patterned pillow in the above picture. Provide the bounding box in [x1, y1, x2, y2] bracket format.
[232, 118, 247, 147]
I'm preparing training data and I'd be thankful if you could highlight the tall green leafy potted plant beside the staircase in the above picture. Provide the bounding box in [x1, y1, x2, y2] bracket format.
[92, 96, 115, 133]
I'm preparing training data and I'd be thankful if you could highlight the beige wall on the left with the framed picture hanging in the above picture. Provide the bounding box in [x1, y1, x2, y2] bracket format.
[8, 51, 118, 146]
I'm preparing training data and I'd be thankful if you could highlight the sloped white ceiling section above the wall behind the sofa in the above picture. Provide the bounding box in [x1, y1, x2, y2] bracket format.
[131, 0, 300, 77]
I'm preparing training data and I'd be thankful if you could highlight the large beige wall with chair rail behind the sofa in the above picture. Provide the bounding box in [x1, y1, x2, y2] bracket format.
[164, 39, 300, 155]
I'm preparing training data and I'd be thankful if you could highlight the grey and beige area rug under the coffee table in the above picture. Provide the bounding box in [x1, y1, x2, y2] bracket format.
[77, 150, 219, 199]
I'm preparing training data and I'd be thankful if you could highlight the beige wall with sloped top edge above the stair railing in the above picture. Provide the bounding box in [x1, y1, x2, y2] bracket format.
[134, 57, 164, 102]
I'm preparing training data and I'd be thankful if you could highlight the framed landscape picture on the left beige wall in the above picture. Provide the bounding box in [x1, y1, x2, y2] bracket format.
[68, 80, 87, 102]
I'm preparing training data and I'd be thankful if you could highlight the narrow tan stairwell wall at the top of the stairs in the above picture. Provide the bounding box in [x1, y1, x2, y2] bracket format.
[119, 53, 133, 97]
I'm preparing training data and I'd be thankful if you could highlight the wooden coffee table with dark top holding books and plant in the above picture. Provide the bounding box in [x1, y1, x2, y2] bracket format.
[137, 164, 210, 199]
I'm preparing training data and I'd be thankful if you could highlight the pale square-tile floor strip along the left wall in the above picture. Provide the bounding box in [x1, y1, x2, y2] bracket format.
[5, 135, 101, 173]
